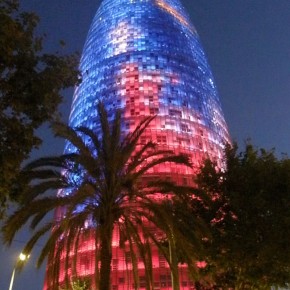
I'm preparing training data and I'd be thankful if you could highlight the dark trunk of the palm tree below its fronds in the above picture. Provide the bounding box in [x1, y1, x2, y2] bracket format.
[99, 222, 113, 290]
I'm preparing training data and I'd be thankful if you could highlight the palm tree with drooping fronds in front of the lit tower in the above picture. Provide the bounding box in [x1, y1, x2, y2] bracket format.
[2, 103, 197, 290]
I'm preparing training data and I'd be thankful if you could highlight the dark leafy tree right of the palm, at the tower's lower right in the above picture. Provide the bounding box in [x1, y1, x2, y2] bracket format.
[194, 145, 290, 289]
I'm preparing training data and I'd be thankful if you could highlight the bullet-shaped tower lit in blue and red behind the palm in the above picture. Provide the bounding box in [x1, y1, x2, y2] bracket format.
[44, 0, 230, 290]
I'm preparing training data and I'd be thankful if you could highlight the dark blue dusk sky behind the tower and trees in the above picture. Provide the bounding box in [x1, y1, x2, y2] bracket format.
[0, 0, 290, 290]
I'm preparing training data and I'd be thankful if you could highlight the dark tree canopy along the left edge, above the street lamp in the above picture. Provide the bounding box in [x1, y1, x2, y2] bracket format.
[0, 0, 78, 211]
